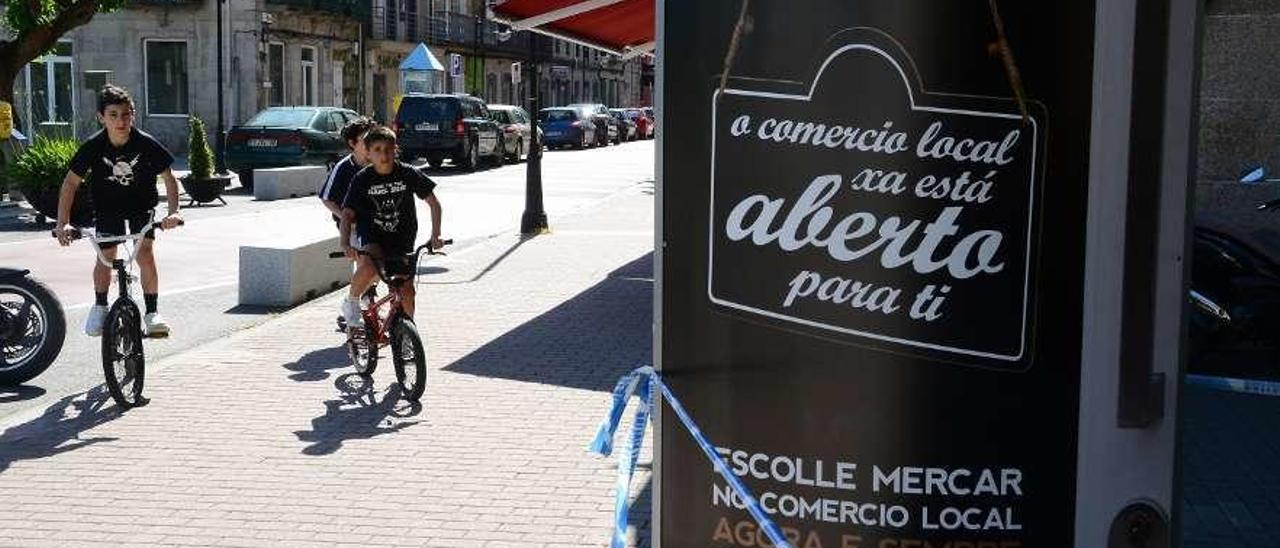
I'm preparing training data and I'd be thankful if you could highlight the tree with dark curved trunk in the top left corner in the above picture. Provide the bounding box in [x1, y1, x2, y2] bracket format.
[0, 0, 125, 125]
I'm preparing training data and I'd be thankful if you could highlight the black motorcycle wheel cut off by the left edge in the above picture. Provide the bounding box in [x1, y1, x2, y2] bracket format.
[0, 268, 67, 385]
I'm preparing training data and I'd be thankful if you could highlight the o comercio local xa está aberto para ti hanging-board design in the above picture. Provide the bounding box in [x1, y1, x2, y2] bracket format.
[708, 28, 1043, 367]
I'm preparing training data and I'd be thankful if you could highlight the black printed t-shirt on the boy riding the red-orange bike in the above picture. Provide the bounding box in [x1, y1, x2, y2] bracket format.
[343, 161, 435, 255]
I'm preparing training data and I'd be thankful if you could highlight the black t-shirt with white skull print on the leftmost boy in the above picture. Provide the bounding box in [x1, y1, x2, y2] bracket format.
[70, 128, 173, 219]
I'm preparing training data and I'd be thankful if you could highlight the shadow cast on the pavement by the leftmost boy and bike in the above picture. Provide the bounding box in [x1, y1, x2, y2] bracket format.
[0, 387, 120, 472]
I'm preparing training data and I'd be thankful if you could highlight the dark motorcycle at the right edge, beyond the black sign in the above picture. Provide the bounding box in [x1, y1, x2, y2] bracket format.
[1188, 200, 1280, 366]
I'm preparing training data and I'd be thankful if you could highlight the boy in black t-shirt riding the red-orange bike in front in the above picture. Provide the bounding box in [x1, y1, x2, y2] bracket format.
[339, 127, 442, 328]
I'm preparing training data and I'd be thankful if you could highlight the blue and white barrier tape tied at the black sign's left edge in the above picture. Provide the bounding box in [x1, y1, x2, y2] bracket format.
[590, 366, 791, 548]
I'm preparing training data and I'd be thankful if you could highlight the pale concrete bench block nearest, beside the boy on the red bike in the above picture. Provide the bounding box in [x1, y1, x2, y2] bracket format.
[239, 236, 351, 306]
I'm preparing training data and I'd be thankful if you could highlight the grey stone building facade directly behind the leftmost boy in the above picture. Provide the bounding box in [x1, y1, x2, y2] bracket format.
[7, 0, 257, 152]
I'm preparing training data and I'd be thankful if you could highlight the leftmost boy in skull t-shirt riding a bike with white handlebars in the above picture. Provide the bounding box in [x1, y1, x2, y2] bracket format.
[54, 85, 182, 337]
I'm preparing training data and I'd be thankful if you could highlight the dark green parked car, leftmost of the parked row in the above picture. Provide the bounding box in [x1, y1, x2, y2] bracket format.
[227, 106, 360, 188]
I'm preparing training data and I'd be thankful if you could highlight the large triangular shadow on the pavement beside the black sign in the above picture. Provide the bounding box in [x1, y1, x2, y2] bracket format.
[444, 254, 653, 392]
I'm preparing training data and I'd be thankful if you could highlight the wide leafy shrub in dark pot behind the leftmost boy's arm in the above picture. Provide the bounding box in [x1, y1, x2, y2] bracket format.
[5, 136, 93, 227]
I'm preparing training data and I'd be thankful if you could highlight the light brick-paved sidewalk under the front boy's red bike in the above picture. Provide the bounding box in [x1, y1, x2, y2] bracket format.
[0, 187, 653, 547]
